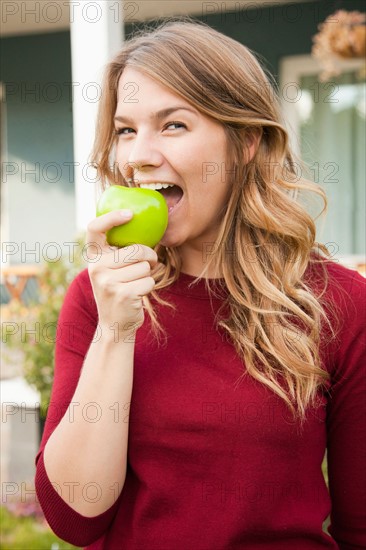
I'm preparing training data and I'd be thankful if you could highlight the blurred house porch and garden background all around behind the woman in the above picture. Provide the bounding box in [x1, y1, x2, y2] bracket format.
[0, 0, 366, 550]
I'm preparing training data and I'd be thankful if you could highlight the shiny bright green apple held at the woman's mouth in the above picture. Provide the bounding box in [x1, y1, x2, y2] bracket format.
[97, 185, 168, 248]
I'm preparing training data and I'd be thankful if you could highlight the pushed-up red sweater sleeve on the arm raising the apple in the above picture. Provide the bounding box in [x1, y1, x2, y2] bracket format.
[35, 270, 119, 546]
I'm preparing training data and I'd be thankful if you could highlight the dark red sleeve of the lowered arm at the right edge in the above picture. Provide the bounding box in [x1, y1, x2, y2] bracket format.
[327, 270, 366, 550]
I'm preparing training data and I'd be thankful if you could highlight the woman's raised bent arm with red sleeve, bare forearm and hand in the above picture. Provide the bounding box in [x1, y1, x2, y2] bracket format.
[36, 212, 157, 545]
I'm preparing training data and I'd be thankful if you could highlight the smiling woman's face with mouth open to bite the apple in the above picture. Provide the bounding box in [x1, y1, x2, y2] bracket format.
[115, 67, 230, 263]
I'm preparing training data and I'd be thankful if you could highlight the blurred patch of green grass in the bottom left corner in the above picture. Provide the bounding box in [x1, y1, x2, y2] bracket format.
[0, 506, 80, 550]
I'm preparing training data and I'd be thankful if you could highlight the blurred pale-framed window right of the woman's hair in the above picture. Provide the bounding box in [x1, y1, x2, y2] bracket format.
[280, 56, 366, 267]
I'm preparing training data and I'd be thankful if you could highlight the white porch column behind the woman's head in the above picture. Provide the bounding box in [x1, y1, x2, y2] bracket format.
[70, 0, 124, 232]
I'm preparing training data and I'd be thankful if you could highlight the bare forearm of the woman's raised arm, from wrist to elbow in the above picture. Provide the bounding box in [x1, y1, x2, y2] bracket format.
[44, 324, 134, 517]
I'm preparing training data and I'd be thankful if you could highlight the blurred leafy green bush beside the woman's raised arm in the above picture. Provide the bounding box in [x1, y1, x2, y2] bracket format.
[2, 235, 85, 418]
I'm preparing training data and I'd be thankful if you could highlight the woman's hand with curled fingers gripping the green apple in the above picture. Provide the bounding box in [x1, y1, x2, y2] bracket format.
[86, 210, 158, 337]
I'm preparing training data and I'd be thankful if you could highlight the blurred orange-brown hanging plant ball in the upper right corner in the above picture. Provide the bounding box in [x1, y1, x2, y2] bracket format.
[312, 10, 366, 81]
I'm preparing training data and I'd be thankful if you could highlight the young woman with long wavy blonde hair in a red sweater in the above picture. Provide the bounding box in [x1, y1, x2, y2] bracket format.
[36, 21, 366, 550]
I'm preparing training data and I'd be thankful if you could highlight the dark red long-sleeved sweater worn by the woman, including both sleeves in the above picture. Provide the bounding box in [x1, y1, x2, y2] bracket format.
[36, 263, 366, 550]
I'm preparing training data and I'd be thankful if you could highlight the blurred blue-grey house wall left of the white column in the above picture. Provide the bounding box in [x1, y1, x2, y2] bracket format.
[0, 32, 75, 264]
